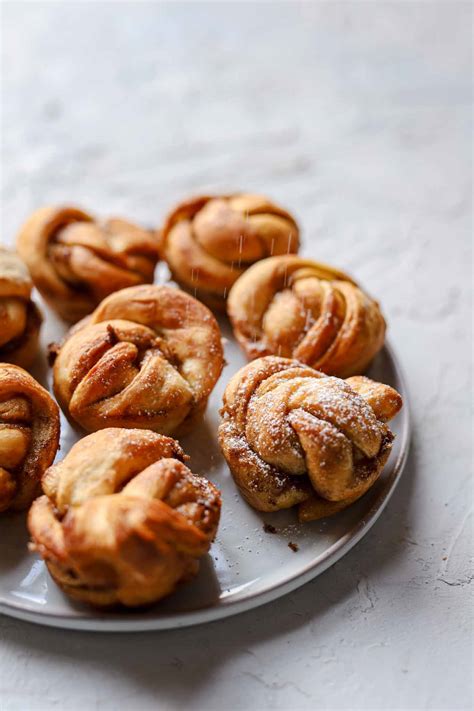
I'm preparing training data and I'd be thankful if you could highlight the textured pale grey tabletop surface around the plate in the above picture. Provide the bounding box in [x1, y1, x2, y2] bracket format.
[0, 2, 473, 710]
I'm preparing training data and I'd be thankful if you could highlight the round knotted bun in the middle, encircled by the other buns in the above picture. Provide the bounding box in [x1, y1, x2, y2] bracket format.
[54, 286, 224, 434]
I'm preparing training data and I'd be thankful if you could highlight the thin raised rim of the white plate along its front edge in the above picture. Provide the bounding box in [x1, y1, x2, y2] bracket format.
[0, 340, 411, 633]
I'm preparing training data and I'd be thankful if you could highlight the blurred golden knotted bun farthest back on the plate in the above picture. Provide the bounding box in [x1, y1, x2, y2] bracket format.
[162, 194, 299, 311]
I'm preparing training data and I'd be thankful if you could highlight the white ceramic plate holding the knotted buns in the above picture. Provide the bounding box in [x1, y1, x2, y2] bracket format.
[0, 298, 410, 632]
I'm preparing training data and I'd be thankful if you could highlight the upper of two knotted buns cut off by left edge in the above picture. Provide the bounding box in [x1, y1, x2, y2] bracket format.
[0, 248, 42, 368]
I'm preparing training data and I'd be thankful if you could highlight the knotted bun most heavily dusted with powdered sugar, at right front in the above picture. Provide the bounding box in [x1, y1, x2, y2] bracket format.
[219, 356, 402, 521]
